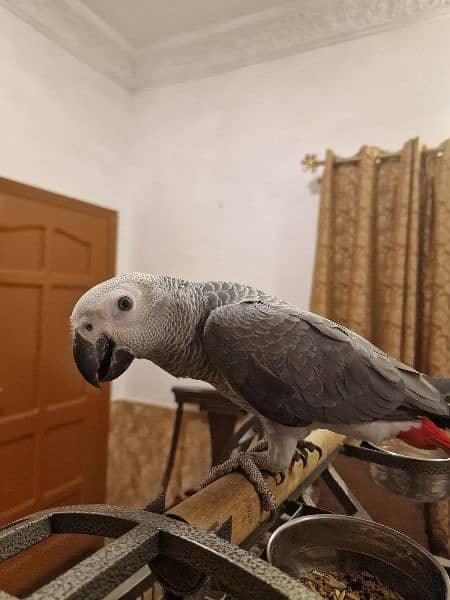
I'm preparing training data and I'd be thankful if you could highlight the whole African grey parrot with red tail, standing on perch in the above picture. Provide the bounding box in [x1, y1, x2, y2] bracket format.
[71, 273, 450, 509]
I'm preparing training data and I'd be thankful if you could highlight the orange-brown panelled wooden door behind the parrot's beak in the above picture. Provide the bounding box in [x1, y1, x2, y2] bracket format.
[0, 179, 116, 589]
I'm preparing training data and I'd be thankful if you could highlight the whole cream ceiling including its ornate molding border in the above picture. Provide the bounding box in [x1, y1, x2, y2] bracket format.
[0, 0, 450, 91]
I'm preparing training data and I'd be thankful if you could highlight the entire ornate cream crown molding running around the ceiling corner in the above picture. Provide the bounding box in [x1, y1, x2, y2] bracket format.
[0, 0, 450, 90]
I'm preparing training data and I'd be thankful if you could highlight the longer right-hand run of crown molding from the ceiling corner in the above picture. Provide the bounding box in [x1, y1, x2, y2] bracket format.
[136, 0, 450, 88]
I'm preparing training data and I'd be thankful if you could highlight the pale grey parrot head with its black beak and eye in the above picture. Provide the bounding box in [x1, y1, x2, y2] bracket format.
[70, 273, 167, 387]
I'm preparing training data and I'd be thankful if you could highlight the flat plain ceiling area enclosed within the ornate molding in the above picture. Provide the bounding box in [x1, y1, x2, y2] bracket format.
[83, 0, 288, 47]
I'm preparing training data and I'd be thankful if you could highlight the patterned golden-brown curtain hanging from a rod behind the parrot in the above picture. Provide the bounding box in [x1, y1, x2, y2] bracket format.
[311, 139, 450, 552]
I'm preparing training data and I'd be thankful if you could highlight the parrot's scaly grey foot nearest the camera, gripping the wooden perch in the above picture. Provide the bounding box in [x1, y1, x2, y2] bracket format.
[200, 452, 277, 513]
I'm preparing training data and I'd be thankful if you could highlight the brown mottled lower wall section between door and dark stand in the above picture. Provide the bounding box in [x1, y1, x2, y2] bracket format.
[107, 400, 211, 507]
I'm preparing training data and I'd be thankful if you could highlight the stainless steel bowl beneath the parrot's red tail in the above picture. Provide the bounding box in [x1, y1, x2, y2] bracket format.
[368, 440, 450, 502]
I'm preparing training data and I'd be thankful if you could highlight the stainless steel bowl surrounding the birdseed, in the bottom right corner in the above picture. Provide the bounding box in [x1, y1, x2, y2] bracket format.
[267, 515, 450, 600]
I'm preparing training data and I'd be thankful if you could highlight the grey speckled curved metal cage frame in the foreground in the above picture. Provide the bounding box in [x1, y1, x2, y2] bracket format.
[0, 505, 318, 600]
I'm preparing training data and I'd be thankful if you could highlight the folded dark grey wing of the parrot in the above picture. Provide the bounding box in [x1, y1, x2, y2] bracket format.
[204, 301, 449, 426]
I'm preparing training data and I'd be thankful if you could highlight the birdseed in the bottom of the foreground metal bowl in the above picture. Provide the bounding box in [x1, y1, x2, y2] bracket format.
[300, 570, 406, 600]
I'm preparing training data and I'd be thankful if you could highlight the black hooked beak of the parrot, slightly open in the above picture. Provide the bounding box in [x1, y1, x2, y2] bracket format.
[73, 332, 134, 387]
